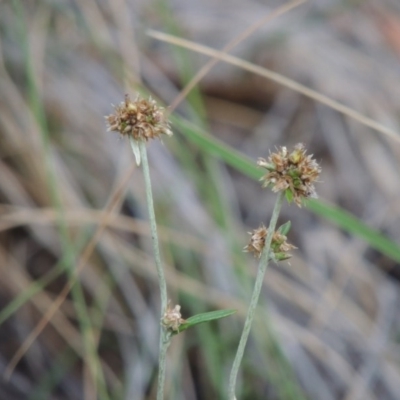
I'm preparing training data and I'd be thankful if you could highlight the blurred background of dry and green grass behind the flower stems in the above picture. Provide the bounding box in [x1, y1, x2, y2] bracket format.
[0, 0, 400, 400]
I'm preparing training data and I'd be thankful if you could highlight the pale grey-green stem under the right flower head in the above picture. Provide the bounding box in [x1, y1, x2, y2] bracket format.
[228, 192, 285, 400]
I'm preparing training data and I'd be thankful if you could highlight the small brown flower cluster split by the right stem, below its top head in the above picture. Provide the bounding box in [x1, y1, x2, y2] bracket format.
[244, 225, 296, 261]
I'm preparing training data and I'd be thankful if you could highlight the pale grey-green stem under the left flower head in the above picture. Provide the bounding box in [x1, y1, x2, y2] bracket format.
[137, 139, 171, 400]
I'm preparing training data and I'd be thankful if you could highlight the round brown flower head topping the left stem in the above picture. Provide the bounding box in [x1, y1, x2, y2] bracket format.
[105, 95, 172, 141]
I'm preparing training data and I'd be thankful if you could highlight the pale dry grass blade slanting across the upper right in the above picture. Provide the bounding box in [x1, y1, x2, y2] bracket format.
[147, 30, 400, 143]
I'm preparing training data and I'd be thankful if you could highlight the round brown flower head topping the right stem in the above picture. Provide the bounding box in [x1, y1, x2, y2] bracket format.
[257, 143, 321, 207]
